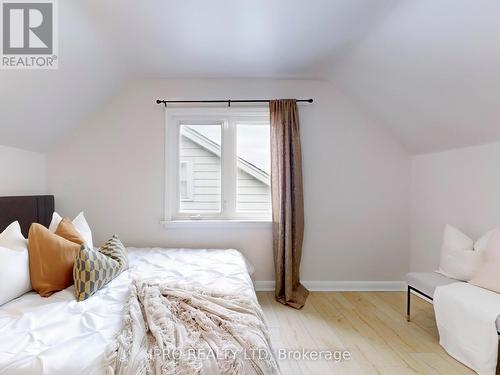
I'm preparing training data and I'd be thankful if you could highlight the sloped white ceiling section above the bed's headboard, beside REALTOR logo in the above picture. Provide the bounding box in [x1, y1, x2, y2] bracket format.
[0, 0, 126, 151]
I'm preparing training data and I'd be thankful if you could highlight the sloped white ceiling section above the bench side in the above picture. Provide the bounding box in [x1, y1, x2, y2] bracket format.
[330, 0, 500, 153]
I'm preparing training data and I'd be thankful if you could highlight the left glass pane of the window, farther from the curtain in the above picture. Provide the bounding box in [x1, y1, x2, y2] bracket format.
[179, 124, 222, 215]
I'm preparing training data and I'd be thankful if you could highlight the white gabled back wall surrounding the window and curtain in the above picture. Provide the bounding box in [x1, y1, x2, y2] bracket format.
[48, 80, 410, 281]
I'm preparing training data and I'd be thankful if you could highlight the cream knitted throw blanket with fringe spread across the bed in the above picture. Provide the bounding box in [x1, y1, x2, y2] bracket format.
[105, 280, 280, 375]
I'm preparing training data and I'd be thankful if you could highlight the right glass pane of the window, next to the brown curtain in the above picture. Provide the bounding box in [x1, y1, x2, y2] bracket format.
[236, 123, 271, 218]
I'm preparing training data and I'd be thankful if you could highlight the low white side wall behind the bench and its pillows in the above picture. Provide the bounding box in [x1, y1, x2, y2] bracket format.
[410, 143, 500, 271]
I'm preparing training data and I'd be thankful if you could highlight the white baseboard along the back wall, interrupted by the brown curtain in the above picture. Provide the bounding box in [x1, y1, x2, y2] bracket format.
[254, 281, 406, 292]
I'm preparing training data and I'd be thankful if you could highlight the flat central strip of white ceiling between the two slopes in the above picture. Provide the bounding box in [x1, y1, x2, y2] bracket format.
[85, 0, 396, 78]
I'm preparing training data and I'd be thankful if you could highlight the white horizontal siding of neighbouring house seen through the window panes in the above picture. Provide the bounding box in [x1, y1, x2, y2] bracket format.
[180, 136, 271, 214]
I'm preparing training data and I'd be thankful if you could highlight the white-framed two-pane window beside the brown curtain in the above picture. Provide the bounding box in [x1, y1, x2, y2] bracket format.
[165, 108, 271, 221]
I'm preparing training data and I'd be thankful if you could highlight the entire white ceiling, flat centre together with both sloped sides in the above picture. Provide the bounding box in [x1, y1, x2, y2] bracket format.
[0, 0, 500, 153]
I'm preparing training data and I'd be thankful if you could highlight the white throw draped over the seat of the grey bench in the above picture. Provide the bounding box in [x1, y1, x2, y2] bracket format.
[434, 283, 500, 375]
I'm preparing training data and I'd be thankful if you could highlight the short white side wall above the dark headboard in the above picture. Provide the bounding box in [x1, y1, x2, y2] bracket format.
[0, 146, 47, 196]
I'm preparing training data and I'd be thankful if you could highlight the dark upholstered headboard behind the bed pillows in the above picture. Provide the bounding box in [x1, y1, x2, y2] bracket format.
[0, 195, 54, 237]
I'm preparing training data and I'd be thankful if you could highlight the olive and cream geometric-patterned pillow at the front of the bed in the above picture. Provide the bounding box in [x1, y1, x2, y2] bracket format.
[73, 245, 123, 302]
